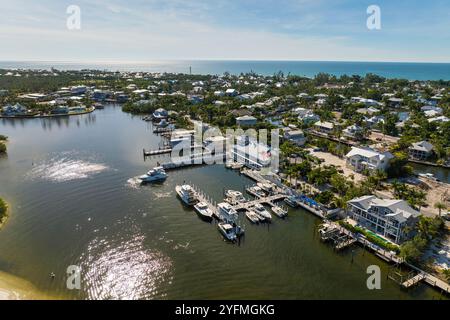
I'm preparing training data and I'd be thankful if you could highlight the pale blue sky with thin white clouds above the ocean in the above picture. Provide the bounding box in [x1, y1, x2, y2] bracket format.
[0, 0, 450, 62]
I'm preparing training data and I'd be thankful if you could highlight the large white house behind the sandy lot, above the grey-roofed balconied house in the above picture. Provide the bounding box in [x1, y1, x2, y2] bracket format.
[345, 147, 394, 172]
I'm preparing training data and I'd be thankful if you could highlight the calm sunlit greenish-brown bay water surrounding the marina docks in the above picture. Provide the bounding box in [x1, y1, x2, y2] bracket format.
[0, 106, 442, 299]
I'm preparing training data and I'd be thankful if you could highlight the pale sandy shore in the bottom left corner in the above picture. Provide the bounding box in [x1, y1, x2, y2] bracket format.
[0, 271, 53, 300]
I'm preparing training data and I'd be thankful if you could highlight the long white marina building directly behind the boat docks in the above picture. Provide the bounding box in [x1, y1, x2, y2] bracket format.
[231, 136, 271, 170]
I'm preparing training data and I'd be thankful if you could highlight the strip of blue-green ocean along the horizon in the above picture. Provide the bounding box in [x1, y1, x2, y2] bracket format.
[0, 60, 450, 80]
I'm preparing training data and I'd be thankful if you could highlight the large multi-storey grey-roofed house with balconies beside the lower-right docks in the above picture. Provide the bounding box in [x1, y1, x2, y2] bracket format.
[347, 195, 420, 244]
